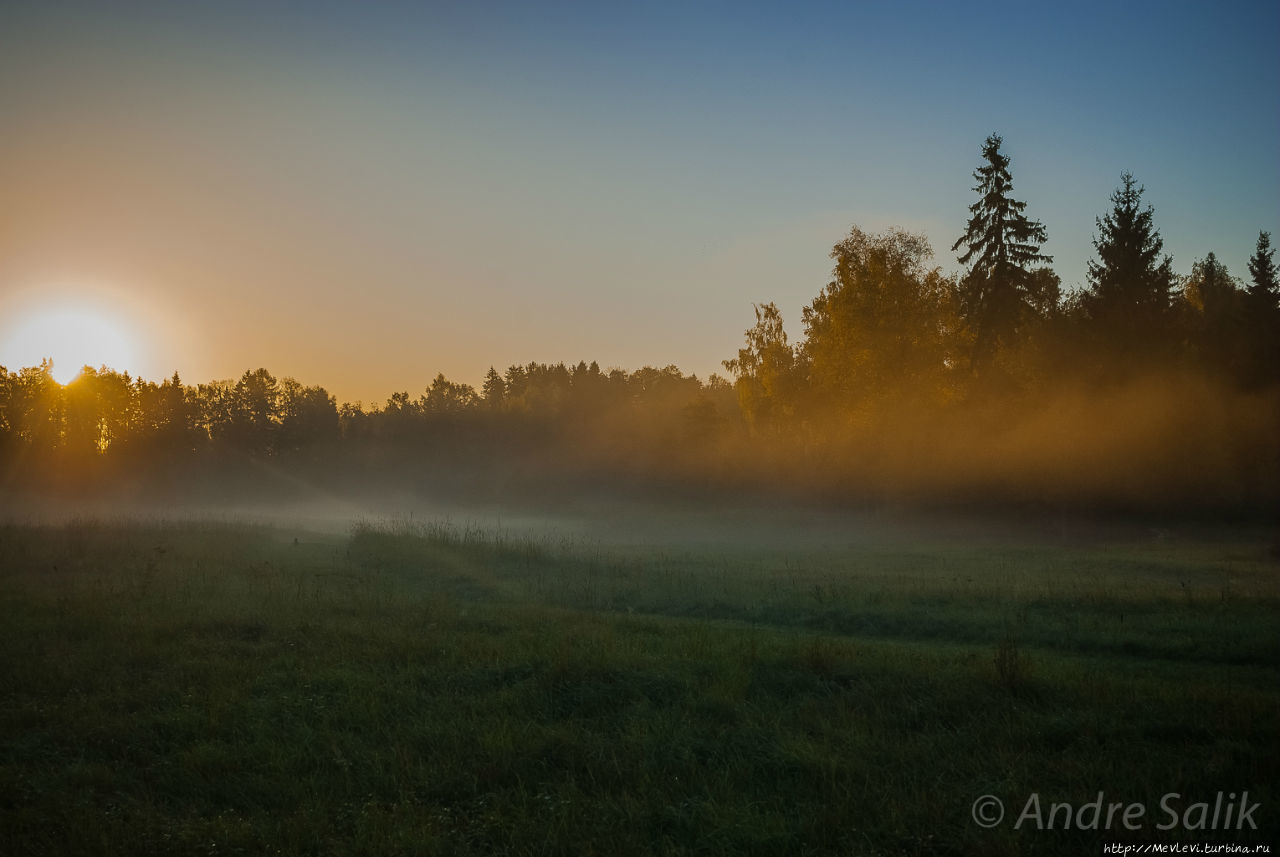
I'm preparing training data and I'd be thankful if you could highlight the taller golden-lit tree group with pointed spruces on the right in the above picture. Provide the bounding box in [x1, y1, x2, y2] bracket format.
[724, 134, 1280, 442]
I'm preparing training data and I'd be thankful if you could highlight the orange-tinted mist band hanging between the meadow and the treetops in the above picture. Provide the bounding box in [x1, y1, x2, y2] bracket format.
[0, 363, 1280, 521]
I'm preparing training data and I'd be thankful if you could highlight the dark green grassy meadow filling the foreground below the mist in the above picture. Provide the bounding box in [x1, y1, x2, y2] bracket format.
[0, 521, 1280, 854]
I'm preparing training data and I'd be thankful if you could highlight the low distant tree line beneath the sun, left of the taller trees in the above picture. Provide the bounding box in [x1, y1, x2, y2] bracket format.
[0, 362, 737, 486]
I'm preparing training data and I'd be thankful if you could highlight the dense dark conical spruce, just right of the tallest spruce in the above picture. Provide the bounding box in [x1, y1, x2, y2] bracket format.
[1084, 173, 1176, 343]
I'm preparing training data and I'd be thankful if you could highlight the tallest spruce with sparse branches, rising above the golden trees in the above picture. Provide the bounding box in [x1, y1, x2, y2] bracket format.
[951, 134, 1053, 368]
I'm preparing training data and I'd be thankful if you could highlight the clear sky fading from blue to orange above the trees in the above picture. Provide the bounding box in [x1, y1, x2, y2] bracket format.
[0, 0, 1280, 404]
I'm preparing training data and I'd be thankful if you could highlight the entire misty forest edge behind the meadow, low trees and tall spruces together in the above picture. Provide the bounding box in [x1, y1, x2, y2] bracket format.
[0, 136, 1280, 512]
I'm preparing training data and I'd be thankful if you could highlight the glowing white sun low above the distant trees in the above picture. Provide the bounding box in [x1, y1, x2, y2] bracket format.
[0, 303, 141, 384]
